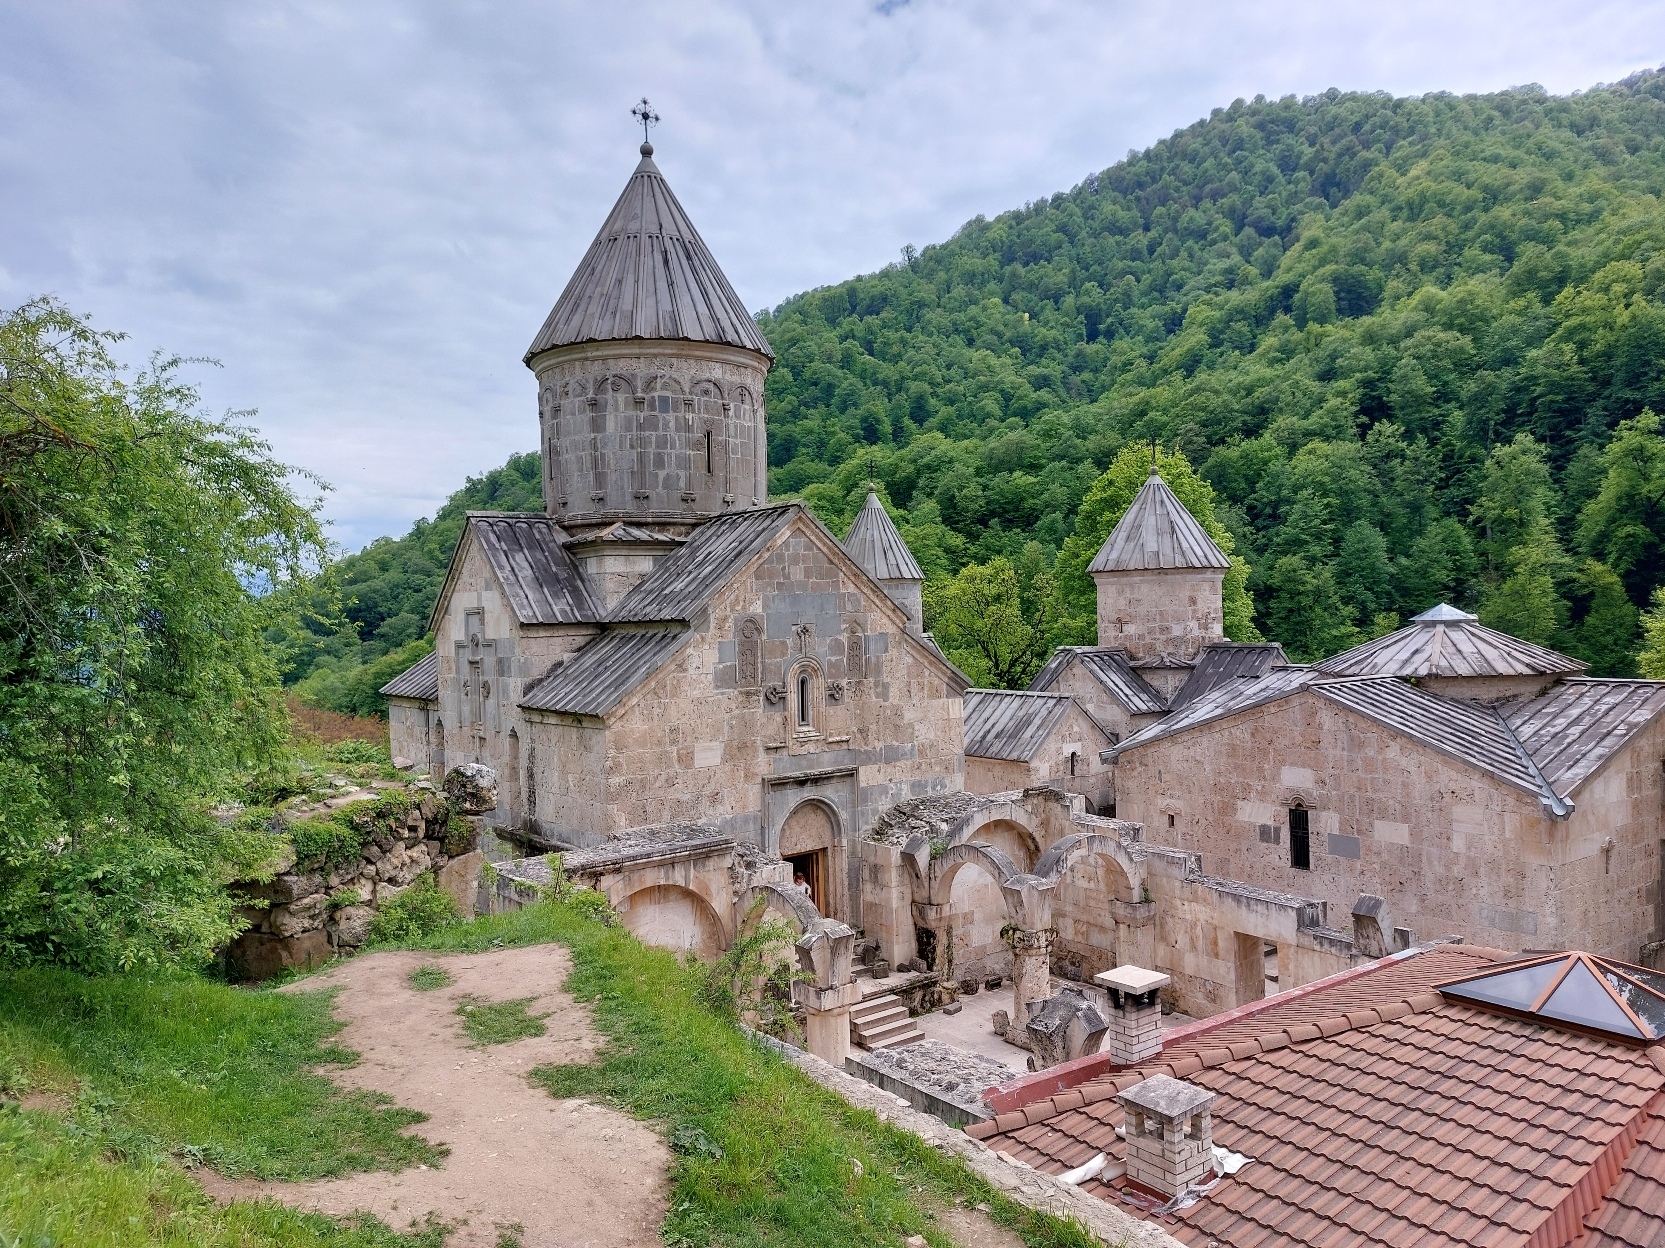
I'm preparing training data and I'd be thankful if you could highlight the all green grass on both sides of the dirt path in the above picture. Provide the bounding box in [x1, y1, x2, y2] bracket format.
[0, 902, 1096, 1248]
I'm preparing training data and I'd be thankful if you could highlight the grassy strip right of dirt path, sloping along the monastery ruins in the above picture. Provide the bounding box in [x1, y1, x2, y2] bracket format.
[409, 902, 1094, 1248]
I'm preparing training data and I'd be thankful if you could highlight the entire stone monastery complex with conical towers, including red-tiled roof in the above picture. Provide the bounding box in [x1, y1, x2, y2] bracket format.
[364, 143, 1665, 1248]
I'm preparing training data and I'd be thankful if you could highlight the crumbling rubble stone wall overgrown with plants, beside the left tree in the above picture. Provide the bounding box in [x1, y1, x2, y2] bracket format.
[226, 787, 480, 980]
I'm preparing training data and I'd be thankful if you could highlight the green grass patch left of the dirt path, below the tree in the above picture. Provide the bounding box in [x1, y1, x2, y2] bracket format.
[0, 967, 443, 1248]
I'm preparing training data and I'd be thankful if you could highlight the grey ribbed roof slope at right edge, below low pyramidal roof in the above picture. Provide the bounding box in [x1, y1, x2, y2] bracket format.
[1503, 677, 1665, 794]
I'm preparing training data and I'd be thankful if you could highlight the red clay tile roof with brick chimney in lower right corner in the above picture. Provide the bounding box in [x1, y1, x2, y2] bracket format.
[967, 958, 1665, 1248]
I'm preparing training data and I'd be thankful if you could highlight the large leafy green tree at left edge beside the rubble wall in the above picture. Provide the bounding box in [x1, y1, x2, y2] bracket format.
[0, 301, 325, 970]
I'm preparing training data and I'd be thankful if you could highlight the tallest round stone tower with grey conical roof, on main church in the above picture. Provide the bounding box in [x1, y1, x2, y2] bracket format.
[526, 143, 774, 534]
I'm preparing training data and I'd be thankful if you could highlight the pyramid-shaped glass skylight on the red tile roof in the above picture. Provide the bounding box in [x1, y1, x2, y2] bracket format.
[1439, 953, 1665, 1043]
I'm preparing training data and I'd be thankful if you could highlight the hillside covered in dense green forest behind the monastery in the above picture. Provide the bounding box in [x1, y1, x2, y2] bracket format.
[288, 72, 1665, 711]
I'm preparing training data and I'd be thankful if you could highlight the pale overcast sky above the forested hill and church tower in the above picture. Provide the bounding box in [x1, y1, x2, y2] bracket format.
[0, 0, 1665, 549]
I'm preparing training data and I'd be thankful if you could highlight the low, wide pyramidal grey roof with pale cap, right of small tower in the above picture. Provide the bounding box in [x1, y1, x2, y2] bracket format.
[1314, 602, 1585, 677]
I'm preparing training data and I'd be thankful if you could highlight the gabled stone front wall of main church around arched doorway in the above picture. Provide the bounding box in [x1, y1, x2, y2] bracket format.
[529, 518, 964, 850]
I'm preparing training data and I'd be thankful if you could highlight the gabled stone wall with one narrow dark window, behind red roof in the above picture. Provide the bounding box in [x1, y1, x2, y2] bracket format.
[1116, 694, 1605, 957]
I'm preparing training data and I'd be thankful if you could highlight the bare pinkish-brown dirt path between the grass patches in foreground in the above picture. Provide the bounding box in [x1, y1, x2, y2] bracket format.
[203, 945, 671, 1248]
